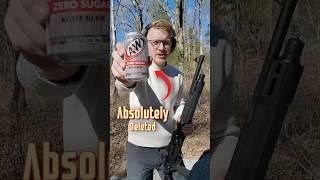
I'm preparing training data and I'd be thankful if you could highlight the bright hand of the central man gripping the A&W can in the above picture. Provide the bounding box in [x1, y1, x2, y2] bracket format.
[111, 43, 129, 85]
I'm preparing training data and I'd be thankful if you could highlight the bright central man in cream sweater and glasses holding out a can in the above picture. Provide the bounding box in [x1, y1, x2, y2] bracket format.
[111, 20, 193, 180]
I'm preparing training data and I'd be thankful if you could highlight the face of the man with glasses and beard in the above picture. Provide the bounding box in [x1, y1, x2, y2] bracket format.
[147, 28, 172, 66]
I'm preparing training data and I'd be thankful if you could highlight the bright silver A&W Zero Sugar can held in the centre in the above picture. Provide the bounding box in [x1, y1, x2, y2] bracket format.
[124, 32, 149, 82]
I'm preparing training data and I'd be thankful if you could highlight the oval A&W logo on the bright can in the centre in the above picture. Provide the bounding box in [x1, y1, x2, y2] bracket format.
[125, 37, 145, 60]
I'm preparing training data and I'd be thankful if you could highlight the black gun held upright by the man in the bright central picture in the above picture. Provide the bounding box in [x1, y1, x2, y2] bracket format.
[162, 55, 205, 180]
